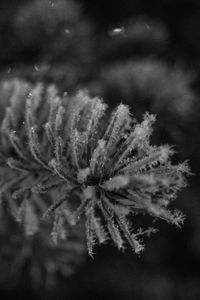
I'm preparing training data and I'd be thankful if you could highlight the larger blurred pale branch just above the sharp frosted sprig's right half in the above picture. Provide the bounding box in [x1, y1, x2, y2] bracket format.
[92, 59, 195, 119]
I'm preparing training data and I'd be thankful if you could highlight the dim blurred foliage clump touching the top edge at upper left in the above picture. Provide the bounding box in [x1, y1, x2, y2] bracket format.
[14, 0, 92, 67]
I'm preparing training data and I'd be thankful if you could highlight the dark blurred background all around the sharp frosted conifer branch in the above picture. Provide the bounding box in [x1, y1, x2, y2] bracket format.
[0, 0, 200, 300]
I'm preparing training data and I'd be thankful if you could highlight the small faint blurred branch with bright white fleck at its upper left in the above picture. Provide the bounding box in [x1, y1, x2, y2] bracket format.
[102, 17, 168, 62]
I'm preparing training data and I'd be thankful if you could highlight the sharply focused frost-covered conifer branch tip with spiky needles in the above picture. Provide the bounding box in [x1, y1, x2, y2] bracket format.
[1, 79, 189, 256]
